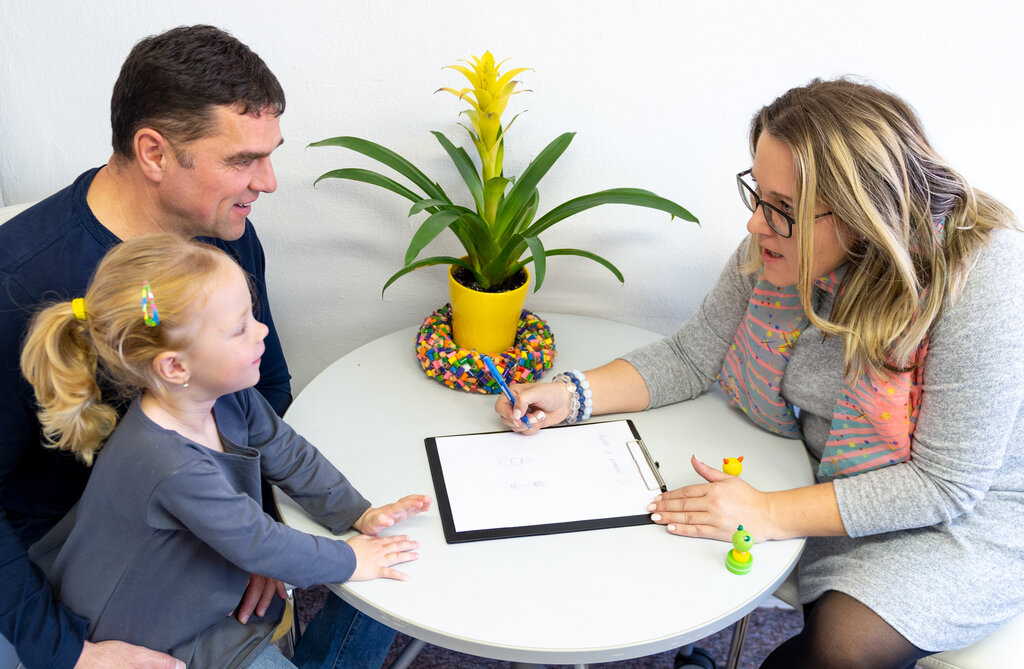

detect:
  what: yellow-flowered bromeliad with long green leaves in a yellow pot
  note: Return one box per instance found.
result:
[309,51,697,352]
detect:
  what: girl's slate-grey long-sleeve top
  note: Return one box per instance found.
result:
[32,388,370,667]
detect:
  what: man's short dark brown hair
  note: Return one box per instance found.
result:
[111,26,285,162]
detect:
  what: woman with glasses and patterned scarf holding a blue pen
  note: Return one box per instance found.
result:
[496,75,1024,667]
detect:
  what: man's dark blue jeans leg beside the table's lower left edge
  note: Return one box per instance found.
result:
[292,593,395,669]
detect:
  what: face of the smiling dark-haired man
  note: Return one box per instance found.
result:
[160,107,283,241]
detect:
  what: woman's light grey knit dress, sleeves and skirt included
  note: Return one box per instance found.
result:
[625,231,1024,651]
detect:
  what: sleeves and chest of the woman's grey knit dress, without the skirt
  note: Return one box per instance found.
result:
[625,231,1024,537]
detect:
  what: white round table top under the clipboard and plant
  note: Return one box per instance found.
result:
[278,313,813,664]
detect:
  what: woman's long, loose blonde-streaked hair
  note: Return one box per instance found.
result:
[748,79,1016,377]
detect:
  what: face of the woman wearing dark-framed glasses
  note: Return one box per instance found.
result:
[746,132,847,286]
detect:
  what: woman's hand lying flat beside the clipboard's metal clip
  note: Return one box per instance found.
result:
[647,456,774,542]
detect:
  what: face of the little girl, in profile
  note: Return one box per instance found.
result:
[186,256,269,399]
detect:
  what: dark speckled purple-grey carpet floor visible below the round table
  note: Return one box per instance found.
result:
[296,587,803,669]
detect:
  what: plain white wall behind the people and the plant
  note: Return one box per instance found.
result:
[0,0,1024,389]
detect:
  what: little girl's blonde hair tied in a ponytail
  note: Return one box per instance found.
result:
[22,234,227,465]
